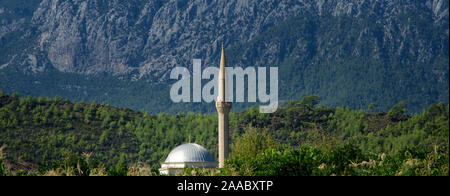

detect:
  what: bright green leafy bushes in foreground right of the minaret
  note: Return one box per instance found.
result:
[223,134,449,176]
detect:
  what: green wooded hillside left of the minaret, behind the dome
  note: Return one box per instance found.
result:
[0,90,217,168]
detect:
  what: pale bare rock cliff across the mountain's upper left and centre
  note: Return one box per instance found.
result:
[32,0,312,78]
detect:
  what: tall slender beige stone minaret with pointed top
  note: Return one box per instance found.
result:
[216,43,231,167]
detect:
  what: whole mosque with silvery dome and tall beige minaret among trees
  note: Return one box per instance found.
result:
[159,43,232,175]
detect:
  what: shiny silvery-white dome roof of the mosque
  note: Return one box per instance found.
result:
[164,143,216,163]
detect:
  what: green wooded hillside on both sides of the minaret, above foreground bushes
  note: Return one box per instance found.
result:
[0,92,449,175]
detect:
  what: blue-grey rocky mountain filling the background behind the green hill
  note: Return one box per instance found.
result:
[0,0,449,113]
